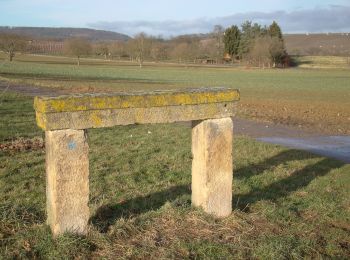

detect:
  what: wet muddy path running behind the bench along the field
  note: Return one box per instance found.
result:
[0,81,350,163]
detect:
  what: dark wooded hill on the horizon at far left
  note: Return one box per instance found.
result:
[0,26,130,41]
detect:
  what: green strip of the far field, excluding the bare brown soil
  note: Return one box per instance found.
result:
[0,57,350,102]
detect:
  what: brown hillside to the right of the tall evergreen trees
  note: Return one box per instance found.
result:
[284,33,350,56]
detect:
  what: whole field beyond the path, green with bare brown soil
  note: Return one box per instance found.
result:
[0,55,350,134]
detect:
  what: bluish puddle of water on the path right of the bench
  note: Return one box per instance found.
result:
[257,136,350,163]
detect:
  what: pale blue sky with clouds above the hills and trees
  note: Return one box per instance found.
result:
[0,0,350,37]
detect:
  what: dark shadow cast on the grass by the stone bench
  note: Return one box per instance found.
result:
[90,150,345,232]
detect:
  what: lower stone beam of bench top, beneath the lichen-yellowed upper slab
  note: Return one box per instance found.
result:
[36,103,236,130]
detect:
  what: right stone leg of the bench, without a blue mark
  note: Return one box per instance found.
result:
[192,118,233,217]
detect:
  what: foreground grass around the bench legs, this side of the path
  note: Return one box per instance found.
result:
[0,94,350,259]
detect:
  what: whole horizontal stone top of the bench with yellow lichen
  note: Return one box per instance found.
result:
[34,88,239,130]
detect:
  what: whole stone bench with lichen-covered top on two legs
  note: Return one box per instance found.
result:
[34,88,239,235]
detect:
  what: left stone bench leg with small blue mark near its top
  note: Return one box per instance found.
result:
[45,130,89,235]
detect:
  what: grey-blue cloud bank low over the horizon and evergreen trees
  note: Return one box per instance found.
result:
[88,5,350,37]
